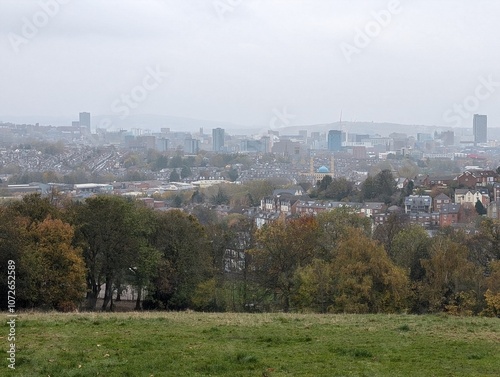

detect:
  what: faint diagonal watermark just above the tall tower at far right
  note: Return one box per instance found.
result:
[443,75,500,126]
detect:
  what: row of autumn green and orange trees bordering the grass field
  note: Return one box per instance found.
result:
[0,195,500,316]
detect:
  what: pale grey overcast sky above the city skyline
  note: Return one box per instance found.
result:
[0,0,500,126]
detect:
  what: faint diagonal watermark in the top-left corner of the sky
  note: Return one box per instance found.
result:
[7,0,71,54]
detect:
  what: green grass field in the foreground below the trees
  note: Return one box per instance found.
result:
[5,312,500,377]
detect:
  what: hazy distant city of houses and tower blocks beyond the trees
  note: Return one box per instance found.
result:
[0,112,500,228]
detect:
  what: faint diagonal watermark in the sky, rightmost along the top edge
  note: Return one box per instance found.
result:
[339,0,403,63]
